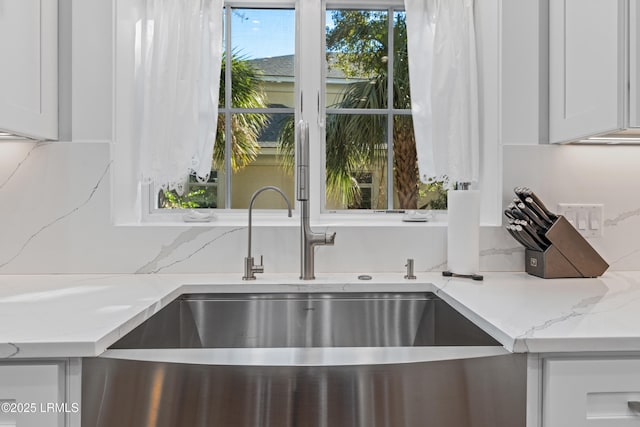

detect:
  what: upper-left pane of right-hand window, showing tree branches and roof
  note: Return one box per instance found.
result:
[326,9,388,108]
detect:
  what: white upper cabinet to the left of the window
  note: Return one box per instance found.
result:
[0,0,58,139]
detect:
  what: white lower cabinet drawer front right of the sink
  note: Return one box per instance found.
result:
[542,358,640,427]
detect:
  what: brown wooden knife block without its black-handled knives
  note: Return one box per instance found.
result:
[525,216,609,279]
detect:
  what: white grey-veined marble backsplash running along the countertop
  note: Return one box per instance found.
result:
[0,142,640,274]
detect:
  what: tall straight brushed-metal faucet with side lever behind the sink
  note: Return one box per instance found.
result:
[296,120,336,280]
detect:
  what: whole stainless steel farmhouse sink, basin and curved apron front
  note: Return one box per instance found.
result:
[82,292,526,427]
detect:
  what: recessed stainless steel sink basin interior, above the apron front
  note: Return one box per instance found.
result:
[110,292,499,349]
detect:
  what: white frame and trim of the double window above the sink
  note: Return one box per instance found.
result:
[112,0,502,226]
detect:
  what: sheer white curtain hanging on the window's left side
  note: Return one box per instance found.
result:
[138,0,223,193]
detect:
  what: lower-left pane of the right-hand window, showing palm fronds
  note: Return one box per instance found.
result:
[325,114,387,210]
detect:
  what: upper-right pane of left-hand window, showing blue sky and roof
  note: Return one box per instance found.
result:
[231,9,295,108]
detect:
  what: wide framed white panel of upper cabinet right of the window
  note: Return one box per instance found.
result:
[549,0,624,142]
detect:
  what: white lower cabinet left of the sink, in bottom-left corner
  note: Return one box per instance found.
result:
[0,360,80,427]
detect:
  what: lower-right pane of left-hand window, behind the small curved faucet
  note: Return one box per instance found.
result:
[231,114,295,209]
